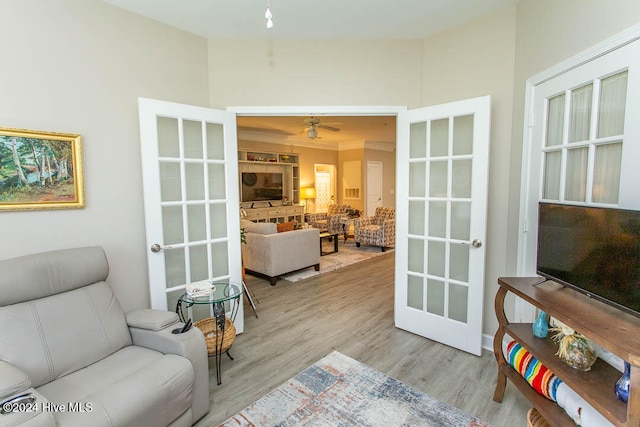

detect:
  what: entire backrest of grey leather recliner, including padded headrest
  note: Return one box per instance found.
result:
[0,247,131,387]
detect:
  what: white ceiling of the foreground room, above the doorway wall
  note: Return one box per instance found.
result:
[103,0,518,40]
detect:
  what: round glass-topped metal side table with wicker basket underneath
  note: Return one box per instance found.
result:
[176,281,242,385]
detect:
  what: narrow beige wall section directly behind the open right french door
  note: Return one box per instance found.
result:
[423,7,516,334]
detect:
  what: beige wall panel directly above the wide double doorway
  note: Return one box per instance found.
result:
[209,40,422,108]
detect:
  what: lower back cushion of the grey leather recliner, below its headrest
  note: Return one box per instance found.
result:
[0,282,131,387]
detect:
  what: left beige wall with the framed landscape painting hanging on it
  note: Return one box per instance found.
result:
[0,0,208,310]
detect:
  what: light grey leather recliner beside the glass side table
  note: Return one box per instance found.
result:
[0,247,209,427]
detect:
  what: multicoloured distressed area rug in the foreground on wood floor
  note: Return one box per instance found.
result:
[221,351,489,427]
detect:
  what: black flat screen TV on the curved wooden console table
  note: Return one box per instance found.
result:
[537,202,640,317]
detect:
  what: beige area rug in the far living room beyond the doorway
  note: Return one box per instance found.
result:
[281,237,393,282]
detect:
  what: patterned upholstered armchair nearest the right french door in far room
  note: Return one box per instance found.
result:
[354,207,396,252]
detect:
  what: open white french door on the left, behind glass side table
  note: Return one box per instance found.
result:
[139,98,244,332]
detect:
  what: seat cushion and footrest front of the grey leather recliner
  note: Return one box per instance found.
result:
[38,346,194,426]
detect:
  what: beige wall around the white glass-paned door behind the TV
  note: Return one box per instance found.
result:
[507,0,640,275]
